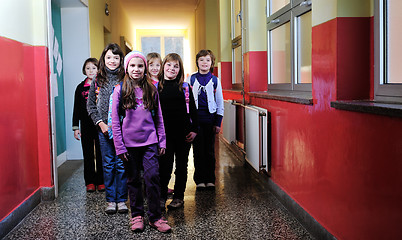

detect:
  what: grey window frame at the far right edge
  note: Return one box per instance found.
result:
[374,0,402,103]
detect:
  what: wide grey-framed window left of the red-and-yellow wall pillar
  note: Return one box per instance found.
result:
[267,0,312,91]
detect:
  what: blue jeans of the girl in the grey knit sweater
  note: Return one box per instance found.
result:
[98,131,127,203]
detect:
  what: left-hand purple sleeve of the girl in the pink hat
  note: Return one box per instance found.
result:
[112,85,127,155]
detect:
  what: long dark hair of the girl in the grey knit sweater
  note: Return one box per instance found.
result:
[96,43,124,86]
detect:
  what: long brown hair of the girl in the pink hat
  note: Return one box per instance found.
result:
[120,57,157,111]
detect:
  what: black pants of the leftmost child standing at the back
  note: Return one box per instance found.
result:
[81,128,103,185]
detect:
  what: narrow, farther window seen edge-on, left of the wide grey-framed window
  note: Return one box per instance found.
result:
[232,0,243,84]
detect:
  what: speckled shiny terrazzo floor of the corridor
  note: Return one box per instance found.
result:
[4,138,313,240]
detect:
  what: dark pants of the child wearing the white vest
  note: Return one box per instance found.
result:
[193,124,216,184]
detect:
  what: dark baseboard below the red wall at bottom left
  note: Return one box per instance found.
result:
[0,189,41,239]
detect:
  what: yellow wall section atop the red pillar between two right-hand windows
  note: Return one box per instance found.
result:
[312,0,374,26]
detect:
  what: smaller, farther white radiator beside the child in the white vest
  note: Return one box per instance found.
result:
[223,100,236,143]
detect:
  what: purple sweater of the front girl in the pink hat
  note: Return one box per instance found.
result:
[112,85,166,155]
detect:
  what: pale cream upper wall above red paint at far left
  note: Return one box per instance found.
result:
[0,0,47,46]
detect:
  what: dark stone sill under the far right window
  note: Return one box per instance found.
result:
[331,100,402,118]
